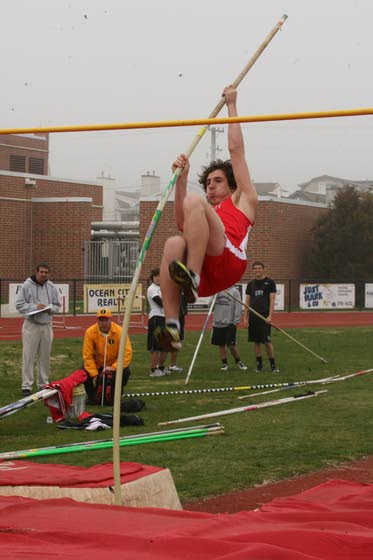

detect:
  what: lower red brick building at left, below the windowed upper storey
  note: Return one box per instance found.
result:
[0,171,102,280]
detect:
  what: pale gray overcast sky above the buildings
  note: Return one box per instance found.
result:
[0,0,373,190]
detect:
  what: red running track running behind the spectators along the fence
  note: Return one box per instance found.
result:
[0,311,373,341]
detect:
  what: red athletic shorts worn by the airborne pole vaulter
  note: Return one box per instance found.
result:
[198,247,247,297]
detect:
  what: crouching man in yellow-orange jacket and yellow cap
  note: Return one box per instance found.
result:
[83,307,132,405]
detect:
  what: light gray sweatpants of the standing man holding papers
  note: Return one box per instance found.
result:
[22,320,53,390]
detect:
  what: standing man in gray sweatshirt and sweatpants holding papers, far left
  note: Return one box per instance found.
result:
[16,262,61,396]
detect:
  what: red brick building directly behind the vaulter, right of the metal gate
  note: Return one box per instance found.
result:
[140,197,326,281]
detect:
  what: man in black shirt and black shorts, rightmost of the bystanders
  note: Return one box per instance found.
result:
[244,261,279,373]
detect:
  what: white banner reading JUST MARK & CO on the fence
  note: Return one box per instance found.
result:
[299,284,355,310]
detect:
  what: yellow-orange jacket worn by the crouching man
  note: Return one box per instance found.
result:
[83,322,132,377]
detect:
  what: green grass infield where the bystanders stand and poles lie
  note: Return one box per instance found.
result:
[0,327,373,501]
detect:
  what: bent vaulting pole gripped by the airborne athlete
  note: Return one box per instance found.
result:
[113,15,287,505]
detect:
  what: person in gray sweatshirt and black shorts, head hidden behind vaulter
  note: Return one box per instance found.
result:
[211,286,247,371]
